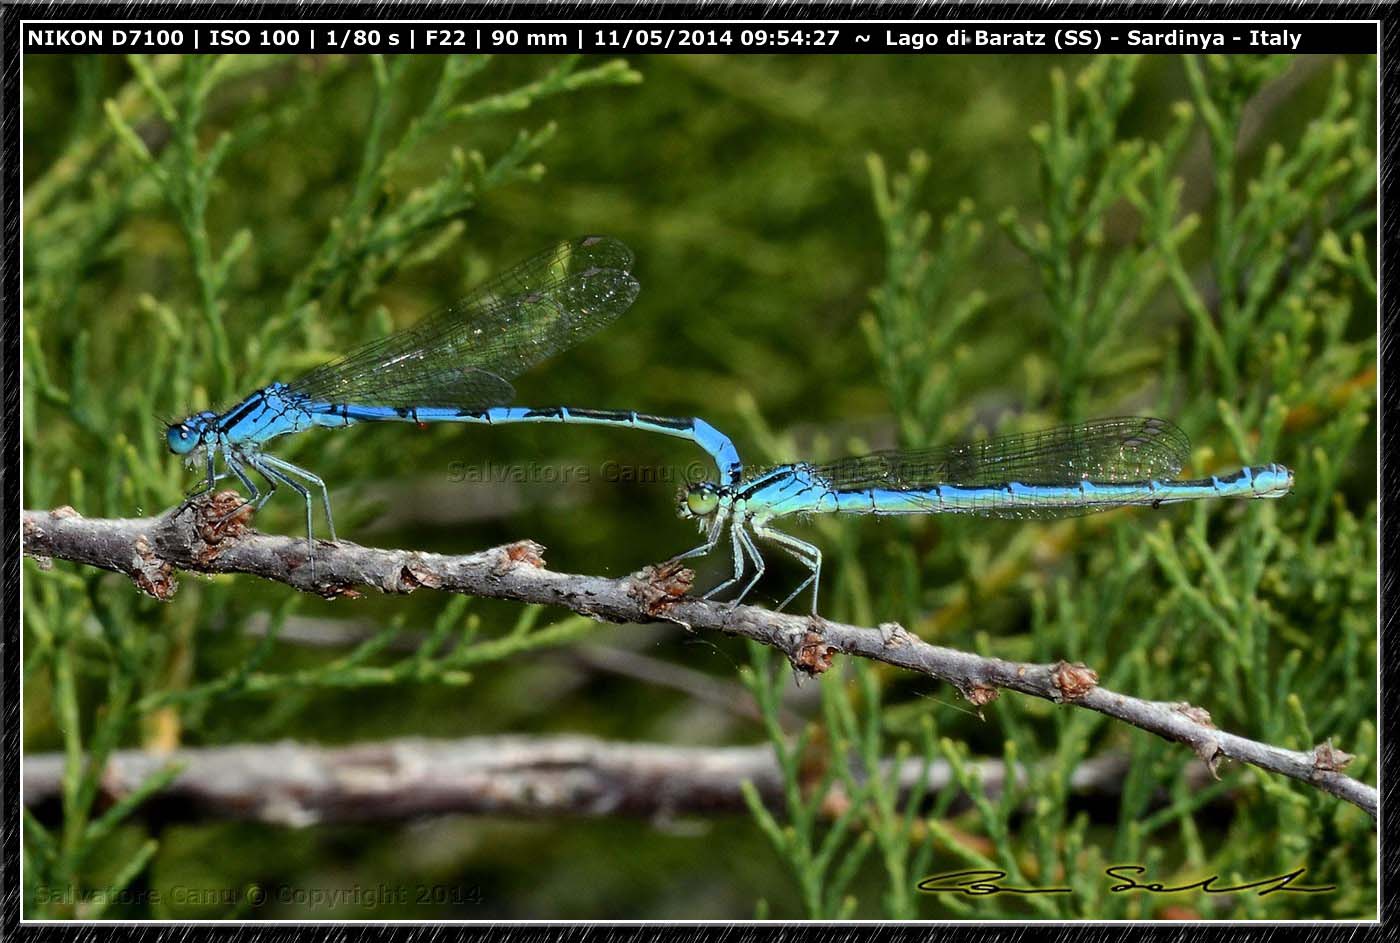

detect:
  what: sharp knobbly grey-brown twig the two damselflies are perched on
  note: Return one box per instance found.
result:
[22,491,1378,818]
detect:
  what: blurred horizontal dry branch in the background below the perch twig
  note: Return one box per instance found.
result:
[16,736,1127,827]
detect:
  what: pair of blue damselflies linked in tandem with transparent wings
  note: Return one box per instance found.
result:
[165,236,1294,613]
